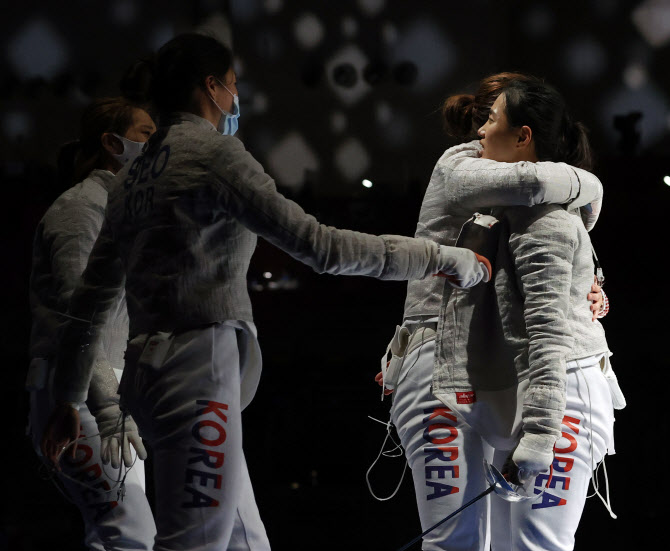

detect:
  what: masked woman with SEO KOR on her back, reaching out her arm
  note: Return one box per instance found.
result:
[45,35,488,551]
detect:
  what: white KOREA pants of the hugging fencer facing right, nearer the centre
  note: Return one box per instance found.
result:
[391,337,493,551]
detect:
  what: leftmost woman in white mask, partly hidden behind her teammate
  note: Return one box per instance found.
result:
[27,98,156,551]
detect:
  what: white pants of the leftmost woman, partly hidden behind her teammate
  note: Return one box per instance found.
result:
[30,376,156,551]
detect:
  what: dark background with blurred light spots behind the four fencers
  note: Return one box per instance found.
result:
[0,0,670,550]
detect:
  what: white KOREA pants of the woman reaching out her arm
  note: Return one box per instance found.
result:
[122,324,270,551]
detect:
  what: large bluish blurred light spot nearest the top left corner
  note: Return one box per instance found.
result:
[7,19,69,79]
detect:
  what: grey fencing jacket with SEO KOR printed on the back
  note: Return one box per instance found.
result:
[54,113,446,402]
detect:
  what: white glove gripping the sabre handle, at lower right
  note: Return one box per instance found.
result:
[503,433,556,485]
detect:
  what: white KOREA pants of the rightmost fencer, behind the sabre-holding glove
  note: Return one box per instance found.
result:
[491,364,614,551]
